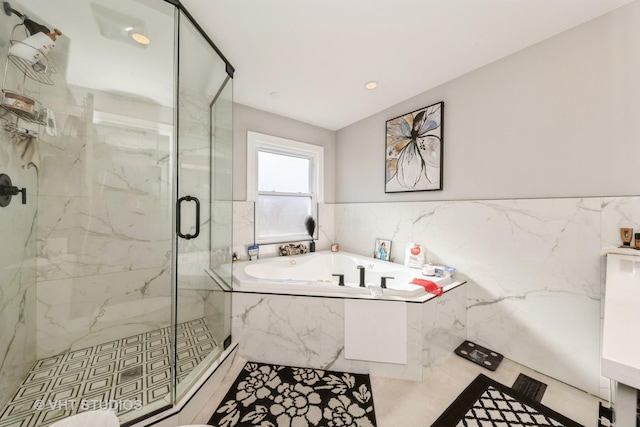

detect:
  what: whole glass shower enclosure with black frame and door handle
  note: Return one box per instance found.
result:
[0,0,233,427]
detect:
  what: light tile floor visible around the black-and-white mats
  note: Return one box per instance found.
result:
[193,354,601,427]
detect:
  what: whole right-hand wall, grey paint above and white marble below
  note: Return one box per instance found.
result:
[335,1,640,397]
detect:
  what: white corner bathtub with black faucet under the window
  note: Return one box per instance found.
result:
[233,251,462,301]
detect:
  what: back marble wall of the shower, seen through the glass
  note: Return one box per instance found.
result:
[32,85,220,358]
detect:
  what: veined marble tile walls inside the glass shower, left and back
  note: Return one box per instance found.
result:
[0,15,231,412]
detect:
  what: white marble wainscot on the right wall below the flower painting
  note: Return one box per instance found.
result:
[335,197,640,397]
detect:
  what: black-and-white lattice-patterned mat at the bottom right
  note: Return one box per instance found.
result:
[431,374,583,427]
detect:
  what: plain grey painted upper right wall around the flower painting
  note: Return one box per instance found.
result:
[336,1,640,203]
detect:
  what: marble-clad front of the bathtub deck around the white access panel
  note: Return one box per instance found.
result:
[232,285,467,380]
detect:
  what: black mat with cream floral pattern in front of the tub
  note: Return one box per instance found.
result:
[209,362,376,427]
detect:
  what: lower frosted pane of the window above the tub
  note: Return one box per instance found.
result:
[256,195,312,242]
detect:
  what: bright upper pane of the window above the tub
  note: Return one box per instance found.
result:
[258,151,311,193]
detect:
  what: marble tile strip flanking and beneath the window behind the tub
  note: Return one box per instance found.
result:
[233,201,335,260]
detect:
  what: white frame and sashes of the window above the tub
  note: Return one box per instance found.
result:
[247,131,324,244]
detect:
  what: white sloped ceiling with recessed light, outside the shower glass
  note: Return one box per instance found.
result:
[182,0,640,130]
